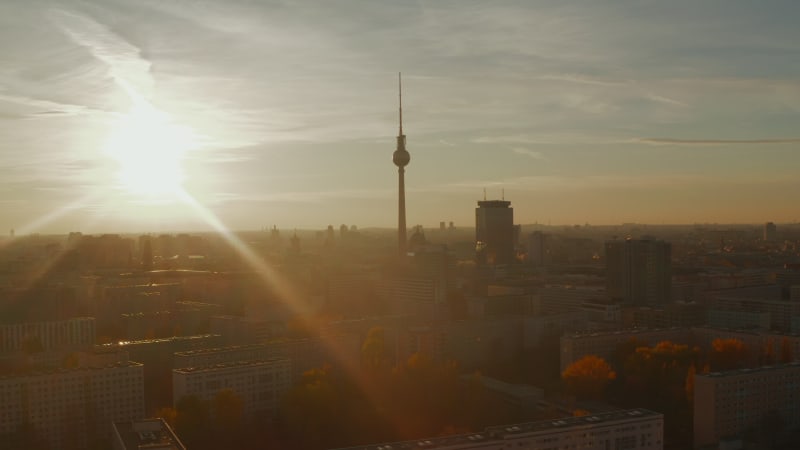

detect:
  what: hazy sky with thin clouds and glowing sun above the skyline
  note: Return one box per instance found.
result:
[0,0,800,235]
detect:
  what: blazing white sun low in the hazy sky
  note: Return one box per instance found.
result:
[105,92,194,199]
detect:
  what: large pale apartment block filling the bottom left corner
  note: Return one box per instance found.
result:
[0,362,144,449]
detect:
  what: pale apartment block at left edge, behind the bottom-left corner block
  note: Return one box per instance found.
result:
[0,317,96,353]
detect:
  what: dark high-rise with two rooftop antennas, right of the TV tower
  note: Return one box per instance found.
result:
[475,200,515,265]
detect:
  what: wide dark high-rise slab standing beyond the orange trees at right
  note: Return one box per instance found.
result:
[605,238,672,306]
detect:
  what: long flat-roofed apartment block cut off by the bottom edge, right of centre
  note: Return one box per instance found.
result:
[332,409,664,450]
